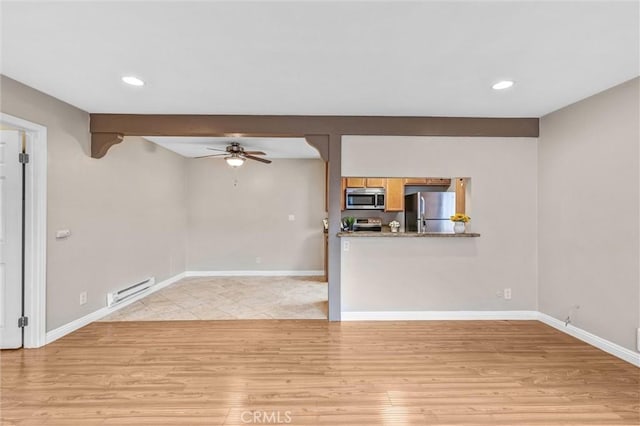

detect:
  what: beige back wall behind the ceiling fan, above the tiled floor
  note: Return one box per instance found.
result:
[187,159,326,271]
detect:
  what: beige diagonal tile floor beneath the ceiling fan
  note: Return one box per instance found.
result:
[102,277,328,321]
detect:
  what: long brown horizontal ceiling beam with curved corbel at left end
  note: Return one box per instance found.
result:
[90,114,539,158]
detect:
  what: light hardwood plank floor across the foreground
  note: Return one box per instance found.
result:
[1,320,640,426]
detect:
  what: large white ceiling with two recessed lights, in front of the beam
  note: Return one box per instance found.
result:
[0,0,640,117]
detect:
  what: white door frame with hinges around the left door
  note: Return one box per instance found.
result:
[0,112,48,348]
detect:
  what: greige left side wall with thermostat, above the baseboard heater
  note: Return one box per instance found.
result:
[0,76,186,330]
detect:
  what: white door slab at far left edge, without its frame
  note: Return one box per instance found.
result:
[0,130,22,349]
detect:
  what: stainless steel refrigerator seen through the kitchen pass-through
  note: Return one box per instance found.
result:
[404,192,456,232]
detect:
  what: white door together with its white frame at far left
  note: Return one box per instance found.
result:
[0,113,47,348]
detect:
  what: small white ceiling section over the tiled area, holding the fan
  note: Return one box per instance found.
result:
[144,136,320,160]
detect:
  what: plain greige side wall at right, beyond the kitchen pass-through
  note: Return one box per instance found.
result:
[538,79,640,350]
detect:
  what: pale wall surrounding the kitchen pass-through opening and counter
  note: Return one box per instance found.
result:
[341,136,537,312]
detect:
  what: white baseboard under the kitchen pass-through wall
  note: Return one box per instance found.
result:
[341,311,538,321]
